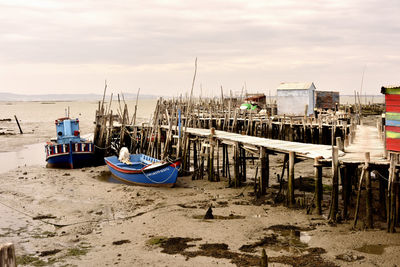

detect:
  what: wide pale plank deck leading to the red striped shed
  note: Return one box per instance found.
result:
[339,125,389,165]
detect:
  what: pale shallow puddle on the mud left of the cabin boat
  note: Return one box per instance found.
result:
[0,143,46,173]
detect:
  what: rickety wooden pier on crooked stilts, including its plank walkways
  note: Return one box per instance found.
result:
[95,93,400,232]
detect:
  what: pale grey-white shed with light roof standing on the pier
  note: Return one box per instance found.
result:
[276,82,315,116]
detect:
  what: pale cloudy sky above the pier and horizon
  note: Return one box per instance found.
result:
[0,0,400,96]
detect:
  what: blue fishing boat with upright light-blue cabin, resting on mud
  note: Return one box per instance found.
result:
[45,118,94,169]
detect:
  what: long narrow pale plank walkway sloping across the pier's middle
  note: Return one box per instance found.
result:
[174,126,344,159]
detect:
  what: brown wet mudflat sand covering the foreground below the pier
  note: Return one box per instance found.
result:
[0,122,400,266]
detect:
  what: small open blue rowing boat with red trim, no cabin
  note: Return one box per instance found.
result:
[104,154,181,187]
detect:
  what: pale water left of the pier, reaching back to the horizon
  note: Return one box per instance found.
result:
[0,99,157,173]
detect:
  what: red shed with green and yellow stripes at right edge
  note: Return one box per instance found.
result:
[381,86,400,152]
